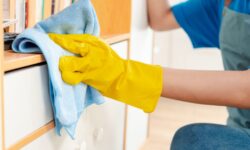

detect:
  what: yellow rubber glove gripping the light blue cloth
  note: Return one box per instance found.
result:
[49,33,163,112]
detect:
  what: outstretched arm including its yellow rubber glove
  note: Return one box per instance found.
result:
[50,34,250,112]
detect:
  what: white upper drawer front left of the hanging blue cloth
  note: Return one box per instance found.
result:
[4,65,53,147]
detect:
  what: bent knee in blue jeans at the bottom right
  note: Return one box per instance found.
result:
[171,124,250,150]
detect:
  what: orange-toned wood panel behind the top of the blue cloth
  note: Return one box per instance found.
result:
[92,0,131,35]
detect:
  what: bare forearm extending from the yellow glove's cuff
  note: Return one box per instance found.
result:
[162,68,250,108]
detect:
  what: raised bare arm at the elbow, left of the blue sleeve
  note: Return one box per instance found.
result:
[147,0,179,31]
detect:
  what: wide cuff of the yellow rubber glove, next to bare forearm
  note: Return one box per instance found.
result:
[103,60,163,113]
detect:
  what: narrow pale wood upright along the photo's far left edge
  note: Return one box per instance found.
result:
[0,0,5,150]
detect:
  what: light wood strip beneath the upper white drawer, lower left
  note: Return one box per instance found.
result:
[8,121,55,150]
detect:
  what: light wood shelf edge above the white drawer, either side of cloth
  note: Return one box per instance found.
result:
[4,34,130,72]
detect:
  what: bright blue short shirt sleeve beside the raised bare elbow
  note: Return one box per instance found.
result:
[172,0,224,48]
